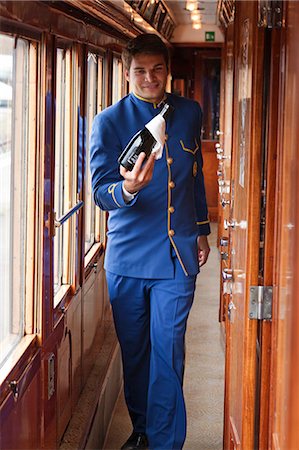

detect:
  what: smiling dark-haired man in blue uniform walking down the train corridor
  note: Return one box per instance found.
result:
[90,34,210,450]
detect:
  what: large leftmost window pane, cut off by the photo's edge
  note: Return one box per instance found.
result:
[0,35,37,366]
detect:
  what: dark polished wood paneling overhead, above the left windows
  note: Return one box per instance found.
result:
[1,0,137,48]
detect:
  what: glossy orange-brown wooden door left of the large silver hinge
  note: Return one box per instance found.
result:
[224,2,263,450]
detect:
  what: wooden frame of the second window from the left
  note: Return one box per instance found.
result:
[52,38,82,308]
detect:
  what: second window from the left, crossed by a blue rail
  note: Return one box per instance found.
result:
[54,48,79,300]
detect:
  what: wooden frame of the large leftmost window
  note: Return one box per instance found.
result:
[0,27,43,386]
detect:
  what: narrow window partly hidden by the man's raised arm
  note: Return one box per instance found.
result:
[84,52,105,254]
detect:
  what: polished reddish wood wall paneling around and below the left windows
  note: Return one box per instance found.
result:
[0,1,123,450]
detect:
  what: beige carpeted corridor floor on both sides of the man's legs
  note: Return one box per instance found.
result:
[104,224,224,450]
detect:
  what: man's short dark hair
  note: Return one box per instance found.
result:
[122,33,169,70]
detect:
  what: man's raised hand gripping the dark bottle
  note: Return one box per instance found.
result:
[120,152,155,194]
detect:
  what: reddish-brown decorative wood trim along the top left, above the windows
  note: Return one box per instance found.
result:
[0,0,129,47]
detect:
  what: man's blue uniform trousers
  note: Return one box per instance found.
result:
[106,257,196,450]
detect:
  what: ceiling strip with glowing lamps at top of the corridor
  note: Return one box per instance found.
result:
[165,0,218,25]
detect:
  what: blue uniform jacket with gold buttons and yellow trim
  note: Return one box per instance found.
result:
[90,93,210,278]
